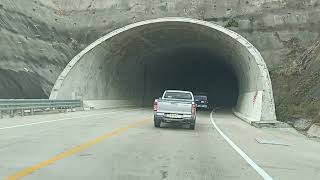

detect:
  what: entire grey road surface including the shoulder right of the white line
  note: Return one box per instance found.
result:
[0,109,320,180]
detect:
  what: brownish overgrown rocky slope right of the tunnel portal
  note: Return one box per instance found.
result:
[271,39,320,122]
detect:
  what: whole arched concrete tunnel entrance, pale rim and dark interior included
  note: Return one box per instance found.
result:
[50,17,276,121]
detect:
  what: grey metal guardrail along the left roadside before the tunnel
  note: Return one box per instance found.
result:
[0,99,83,118]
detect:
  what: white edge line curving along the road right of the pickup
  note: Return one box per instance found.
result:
[210,111,273,180]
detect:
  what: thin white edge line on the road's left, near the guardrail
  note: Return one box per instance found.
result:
[0,110,141,130]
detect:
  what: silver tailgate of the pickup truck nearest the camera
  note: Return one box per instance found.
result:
[158,100,192,114]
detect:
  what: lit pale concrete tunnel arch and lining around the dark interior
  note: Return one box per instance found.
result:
[50,18,276,121]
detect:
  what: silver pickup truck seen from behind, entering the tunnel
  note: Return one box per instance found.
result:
[153,90,197,129]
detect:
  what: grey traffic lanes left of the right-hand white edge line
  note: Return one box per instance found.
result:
[0,109,259,180]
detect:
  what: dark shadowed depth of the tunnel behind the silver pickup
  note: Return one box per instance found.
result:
[139,47,239,108]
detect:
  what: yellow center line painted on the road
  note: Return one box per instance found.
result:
[5,119,149,180]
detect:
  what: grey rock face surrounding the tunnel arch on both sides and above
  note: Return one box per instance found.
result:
[0,0,320,120]
